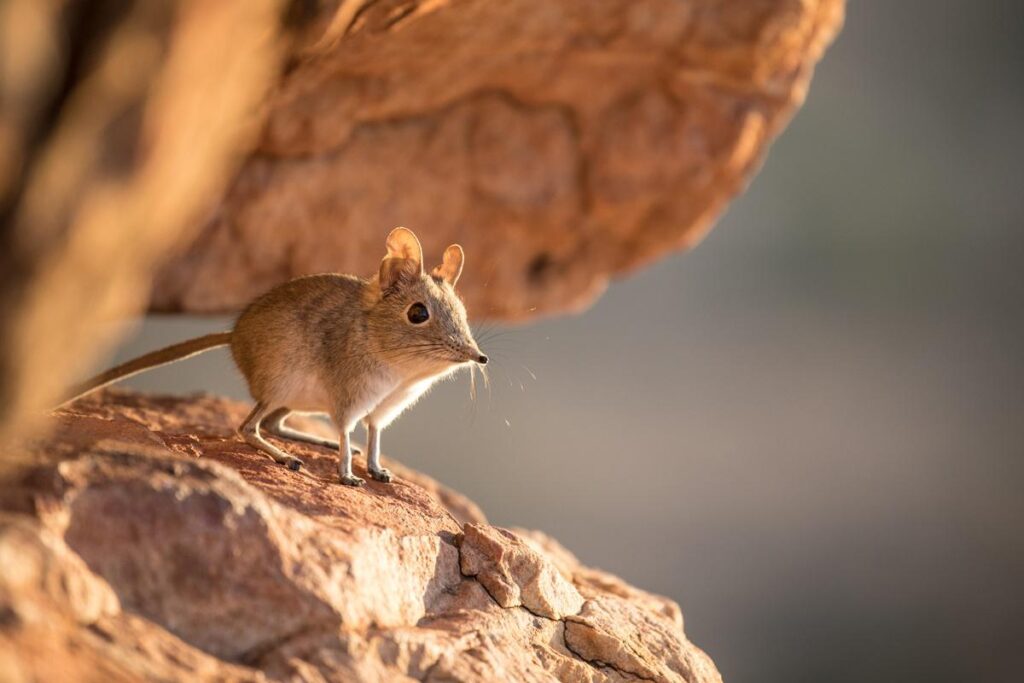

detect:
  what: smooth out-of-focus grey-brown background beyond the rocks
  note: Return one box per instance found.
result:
[103,0,1024,683]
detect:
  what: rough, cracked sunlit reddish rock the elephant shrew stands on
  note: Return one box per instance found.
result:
[0,391,721,683]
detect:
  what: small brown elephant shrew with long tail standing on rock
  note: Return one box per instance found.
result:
[65,227,487,486]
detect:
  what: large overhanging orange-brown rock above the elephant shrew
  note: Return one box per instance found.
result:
[153,0,843,319]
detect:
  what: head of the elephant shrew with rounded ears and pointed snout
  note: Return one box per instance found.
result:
[369,227,487,370]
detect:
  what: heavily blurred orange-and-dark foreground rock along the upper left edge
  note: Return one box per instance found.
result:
[0,0,281,448]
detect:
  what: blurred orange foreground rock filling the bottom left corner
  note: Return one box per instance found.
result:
[0,513,265,683]
